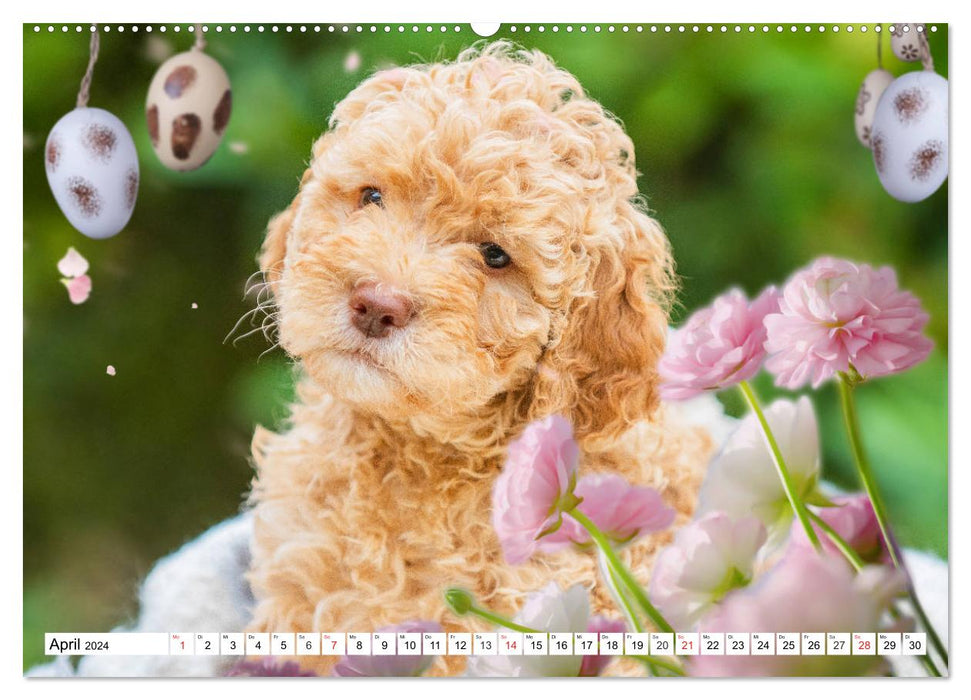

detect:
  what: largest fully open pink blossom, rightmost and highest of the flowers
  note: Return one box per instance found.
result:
[765,258,933,389]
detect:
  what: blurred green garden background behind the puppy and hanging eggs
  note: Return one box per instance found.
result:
[23,25,948,667]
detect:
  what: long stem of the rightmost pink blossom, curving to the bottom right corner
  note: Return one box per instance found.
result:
[837,372,948,667]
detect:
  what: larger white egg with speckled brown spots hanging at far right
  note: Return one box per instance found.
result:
[870,70,948,202]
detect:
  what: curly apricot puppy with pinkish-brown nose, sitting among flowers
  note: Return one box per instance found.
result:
[250,43,711,674]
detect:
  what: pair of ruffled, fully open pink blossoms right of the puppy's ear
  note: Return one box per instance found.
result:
[658,257,933,400]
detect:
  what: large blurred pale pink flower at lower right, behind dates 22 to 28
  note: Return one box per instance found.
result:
[689,549,903,677]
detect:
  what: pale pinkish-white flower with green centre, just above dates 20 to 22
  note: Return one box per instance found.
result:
[650,513,766,631]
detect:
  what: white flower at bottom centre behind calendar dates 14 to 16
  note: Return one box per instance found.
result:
[466,583,590,678]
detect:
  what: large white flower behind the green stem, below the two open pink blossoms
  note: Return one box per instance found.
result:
[698,396,820,544]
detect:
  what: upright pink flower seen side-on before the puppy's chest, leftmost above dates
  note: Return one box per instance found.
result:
[492,416,579,564]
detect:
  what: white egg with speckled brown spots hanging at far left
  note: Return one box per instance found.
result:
[44,107,138,238]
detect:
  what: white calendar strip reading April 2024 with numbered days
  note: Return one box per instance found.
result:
[44,630,927,657]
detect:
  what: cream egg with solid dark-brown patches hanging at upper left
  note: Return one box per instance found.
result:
[145,49,233,170]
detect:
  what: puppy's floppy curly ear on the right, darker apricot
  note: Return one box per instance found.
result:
[530,202,674,446]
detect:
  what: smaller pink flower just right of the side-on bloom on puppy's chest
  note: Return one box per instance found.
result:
[540,474,675,550]
